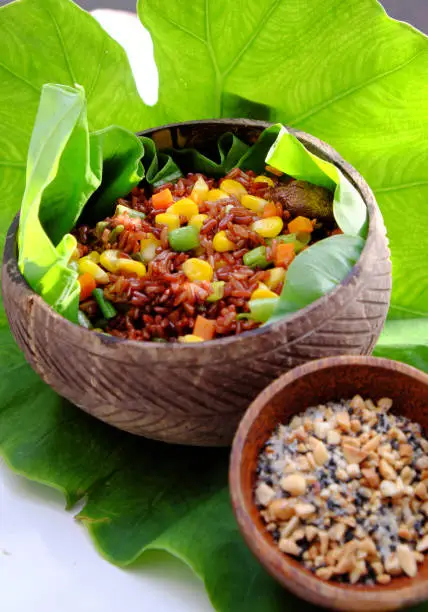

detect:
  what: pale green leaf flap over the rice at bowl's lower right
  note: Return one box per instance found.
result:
[268,235,365,323]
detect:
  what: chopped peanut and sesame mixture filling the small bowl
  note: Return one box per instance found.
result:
[255,395,428,585]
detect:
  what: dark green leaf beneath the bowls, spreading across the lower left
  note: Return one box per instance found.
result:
[0,304,312,612]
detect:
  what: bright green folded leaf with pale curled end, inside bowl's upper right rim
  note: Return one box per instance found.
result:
[266,126,368,237]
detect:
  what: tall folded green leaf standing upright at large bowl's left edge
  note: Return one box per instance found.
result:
[18,85,101,322]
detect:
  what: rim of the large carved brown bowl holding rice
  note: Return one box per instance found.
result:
[3,119,382,362]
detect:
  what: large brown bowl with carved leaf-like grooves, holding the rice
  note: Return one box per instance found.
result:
[3,119,391,446]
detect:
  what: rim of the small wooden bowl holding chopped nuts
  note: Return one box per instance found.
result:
[229,355,428,611]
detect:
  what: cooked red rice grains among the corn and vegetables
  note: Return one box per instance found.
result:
[75,168,328,341]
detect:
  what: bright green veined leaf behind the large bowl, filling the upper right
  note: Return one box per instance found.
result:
[139,0,428,317]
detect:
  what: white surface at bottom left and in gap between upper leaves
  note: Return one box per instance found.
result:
[0,11,213,612]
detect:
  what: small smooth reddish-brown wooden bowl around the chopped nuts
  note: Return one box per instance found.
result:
[229,356,428,612]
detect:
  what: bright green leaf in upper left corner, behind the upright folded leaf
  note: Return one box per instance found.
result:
[0,0,157,251]
